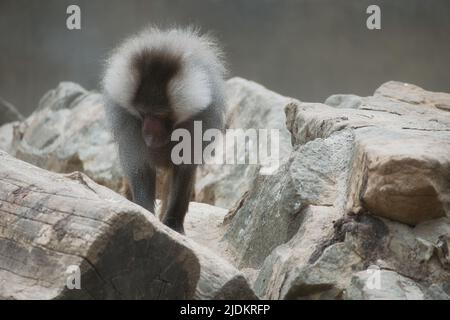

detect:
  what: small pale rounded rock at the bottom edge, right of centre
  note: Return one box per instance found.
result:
[346,268,424,300]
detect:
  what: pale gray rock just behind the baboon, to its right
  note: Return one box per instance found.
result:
[195,78,292,208]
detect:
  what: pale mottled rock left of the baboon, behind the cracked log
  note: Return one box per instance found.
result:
[5,82,123,191]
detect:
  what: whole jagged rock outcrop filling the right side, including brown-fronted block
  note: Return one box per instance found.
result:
[223,83,450,299]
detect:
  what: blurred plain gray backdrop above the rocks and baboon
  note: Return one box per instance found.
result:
[0,0,450,114]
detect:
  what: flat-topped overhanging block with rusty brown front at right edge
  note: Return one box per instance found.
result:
[286,83,450,225]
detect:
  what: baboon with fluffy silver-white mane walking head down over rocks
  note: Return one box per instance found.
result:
[102,28,225,232]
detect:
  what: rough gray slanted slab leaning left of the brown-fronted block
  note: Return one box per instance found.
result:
[225,131,353,268]
